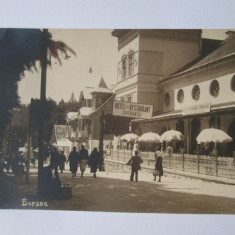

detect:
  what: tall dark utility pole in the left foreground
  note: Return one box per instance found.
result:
[38,29,48,194]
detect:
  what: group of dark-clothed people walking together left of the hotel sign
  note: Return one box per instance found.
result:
[49,145,100,178]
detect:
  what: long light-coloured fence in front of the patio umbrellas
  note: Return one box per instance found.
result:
[106,150,235,179]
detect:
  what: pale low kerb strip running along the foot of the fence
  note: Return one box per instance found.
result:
[105,159,235,185]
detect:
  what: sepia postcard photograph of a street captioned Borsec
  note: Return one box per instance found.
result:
[0,28,235,215]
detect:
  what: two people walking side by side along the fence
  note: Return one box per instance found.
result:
[127,151,163,182]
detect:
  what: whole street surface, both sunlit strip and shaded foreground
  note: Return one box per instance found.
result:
[19,169,235,214]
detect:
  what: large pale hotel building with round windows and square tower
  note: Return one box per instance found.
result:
[112,30,235,156]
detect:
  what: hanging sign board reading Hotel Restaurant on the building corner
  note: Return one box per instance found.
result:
[113,101,153,119]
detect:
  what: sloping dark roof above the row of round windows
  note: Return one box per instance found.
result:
[162,32,235,82]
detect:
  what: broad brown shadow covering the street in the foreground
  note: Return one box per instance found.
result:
[14,174,235,214]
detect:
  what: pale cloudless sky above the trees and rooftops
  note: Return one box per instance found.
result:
[19,29,231,103]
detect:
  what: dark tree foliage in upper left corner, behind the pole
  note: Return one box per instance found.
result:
[0,29,76,140]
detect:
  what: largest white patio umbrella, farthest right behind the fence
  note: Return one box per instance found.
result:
[196,128,233,144]
